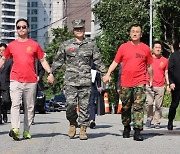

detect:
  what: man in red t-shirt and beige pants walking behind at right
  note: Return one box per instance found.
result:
[146,41,170,129]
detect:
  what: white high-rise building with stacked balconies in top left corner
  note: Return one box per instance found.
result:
[0,0,27,44]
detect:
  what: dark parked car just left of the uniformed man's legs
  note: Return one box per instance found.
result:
[50,92,66,111]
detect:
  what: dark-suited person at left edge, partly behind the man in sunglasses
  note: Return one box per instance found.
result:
[0,43,13,124]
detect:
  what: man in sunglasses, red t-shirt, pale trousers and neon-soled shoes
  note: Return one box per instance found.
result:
[0,18,54,140]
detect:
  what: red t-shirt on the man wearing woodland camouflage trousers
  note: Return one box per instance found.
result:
[114,41,152,87]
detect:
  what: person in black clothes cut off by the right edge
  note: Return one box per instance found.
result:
[167,39,180,130]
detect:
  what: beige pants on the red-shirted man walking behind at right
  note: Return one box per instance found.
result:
[146,86,165,125]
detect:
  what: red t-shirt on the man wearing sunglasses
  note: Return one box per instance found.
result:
[4,39,44,83]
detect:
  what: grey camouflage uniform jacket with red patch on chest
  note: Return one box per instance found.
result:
[52,38,106,86]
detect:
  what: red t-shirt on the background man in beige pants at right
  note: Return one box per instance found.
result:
[147,56,168,87]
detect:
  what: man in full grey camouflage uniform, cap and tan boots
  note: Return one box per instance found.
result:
[52,19,106,140]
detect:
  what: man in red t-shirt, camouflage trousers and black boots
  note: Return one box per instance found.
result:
[103,24,152,141]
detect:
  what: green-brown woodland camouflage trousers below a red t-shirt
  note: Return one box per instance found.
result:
[120,85,146,130]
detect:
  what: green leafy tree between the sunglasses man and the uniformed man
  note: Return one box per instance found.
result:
[44,27,73,95]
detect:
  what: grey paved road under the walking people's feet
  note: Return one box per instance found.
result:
[0,112,180,154]
